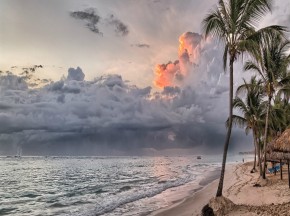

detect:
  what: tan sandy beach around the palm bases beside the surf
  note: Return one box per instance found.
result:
[152,162,290,216]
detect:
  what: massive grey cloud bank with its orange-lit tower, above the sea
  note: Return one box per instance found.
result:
[0,26,253,154]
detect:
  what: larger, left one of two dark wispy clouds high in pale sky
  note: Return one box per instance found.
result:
[70,8,103,35]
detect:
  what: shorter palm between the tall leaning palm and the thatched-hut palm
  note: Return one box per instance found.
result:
[233,76,263,175]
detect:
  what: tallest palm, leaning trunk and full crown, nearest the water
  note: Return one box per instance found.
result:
[202,0,283,197]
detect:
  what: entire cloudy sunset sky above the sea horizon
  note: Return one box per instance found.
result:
[0,0,290,155]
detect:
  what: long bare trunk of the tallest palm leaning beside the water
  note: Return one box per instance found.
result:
[216,56,234,197]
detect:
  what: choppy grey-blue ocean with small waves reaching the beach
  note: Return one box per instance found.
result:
[0,155,253,216]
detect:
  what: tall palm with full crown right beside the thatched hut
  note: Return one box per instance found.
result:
[244,34,290,179]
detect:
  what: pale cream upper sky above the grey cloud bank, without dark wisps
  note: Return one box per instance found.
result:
[0,0,218,86]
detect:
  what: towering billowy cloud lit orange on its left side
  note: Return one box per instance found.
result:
[154,32,216,88]
